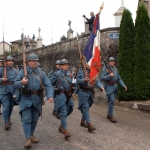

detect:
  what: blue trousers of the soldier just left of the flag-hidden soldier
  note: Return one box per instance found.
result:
[58,103,67,129]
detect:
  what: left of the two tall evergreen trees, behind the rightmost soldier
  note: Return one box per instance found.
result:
[118,9,134,100]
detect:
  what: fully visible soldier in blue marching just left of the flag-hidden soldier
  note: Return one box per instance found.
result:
[51,59,74,139]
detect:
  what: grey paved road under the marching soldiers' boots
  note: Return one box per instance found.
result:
[0,101,150,150]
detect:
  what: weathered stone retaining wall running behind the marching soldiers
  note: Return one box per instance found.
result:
[0,28,119,73]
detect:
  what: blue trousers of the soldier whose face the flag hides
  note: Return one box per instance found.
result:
[81,98,90,123]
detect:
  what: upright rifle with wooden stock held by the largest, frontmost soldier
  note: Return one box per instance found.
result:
[22,33,27,78]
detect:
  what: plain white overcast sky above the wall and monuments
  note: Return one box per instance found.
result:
[0,0,138,45]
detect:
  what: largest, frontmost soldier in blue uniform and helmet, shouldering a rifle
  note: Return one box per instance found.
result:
[15,53,53,148]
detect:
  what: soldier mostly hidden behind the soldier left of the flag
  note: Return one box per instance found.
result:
[48,60,60,119]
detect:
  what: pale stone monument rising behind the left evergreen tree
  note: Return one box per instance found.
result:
[114,0,125,27]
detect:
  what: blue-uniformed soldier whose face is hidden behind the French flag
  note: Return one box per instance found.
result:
[76,64,104,132]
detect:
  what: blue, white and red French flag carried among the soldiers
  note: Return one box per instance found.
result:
[84,14,101,85]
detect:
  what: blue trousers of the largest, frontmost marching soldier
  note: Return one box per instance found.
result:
[21,105,40,139]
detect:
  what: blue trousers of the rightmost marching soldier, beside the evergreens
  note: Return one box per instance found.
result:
[107,92,117,116]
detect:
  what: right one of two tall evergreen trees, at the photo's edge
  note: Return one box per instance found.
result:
[134,4,150,100]
